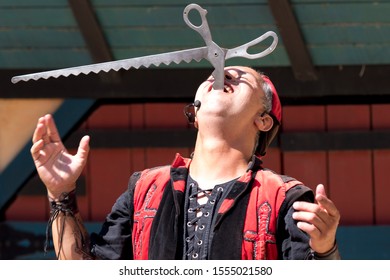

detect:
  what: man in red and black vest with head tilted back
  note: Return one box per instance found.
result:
[31,66,340,259]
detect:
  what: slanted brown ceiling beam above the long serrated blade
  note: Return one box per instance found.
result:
[68,0,120,83]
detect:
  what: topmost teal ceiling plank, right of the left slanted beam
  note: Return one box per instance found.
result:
[90,1,390,29]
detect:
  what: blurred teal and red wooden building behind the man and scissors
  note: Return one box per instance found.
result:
[0,0,390,259]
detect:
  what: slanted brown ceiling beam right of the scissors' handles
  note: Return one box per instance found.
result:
[268,0,318,81]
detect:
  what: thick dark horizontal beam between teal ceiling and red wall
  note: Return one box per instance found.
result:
[4,65,390,105]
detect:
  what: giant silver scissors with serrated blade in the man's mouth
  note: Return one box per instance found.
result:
[11,4,278,90]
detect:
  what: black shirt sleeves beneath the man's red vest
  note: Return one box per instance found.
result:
[91,175,314,260]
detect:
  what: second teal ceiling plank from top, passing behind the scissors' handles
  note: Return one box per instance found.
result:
[100,24,390,48]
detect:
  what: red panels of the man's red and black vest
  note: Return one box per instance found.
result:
[132,155,302,260]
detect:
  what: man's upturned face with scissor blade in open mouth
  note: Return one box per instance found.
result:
[195,66,264,123]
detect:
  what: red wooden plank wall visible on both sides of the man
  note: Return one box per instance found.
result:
[6,103,390,225]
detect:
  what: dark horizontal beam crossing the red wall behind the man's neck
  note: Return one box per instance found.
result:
[65,127,390,151]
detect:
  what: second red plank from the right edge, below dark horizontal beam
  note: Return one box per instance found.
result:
[328,150,375,225]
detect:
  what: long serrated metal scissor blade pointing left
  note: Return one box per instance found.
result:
[11,47,208,84]
